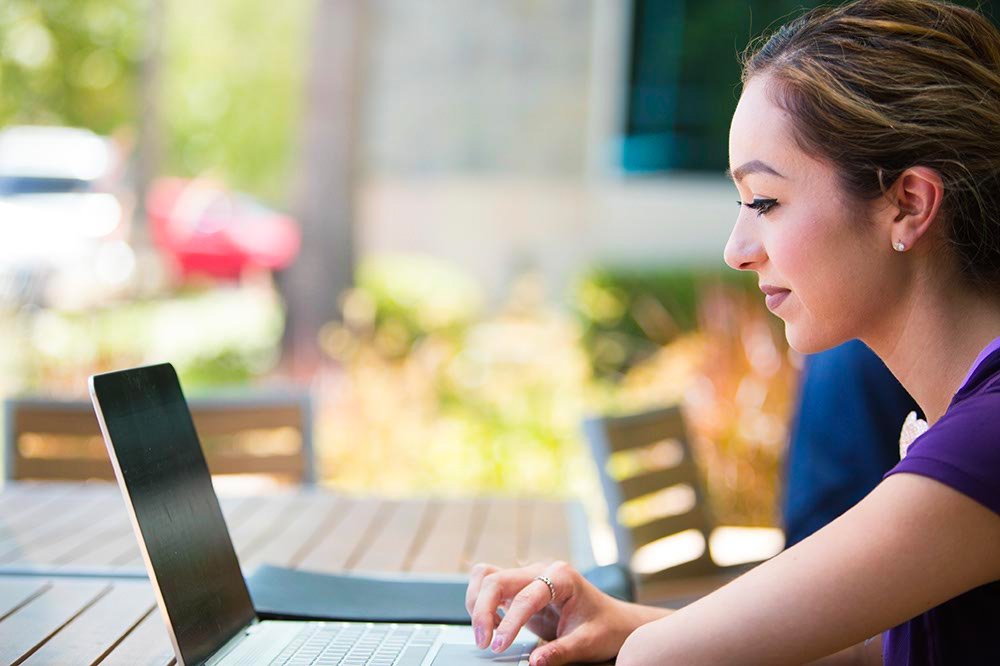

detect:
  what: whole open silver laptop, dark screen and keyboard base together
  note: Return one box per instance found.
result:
[90,363,538,666]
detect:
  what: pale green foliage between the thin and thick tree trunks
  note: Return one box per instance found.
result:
[161,0,311,204]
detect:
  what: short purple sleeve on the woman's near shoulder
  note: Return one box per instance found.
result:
[885,393,1000,514]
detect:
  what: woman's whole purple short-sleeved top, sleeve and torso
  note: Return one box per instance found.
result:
[882,338,1000,666]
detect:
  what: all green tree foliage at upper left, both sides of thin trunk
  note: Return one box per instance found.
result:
[0,0,311,203]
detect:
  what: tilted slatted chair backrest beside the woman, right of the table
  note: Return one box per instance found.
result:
[583,407,718,580]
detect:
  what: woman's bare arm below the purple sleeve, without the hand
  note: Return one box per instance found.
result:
[618,474,1000,666]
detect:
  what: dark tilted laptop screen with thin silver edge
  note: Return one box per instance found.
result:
[90,364,255,664]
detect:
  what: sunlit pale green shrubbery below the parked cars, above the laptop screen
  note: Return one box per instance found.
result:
[18,289,284,394]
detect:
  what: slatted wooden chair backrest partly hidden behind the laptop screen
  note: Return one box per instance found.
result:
[4,392,315,484]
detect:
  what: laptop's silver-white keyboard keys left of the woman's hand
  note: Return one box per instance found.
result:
[271,622,443,666]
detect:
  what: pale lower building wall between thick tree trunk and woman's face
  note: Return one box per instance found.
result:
[359,177,736,300]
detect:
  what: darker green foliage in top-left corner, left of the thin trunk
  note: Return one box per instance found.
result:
[0,0,143,134]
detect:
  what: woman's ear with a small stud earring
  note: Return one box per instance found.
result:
[885,166,944,252]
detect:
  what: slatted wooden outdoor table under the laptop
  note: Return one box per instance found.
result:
[0,482,593,666]
